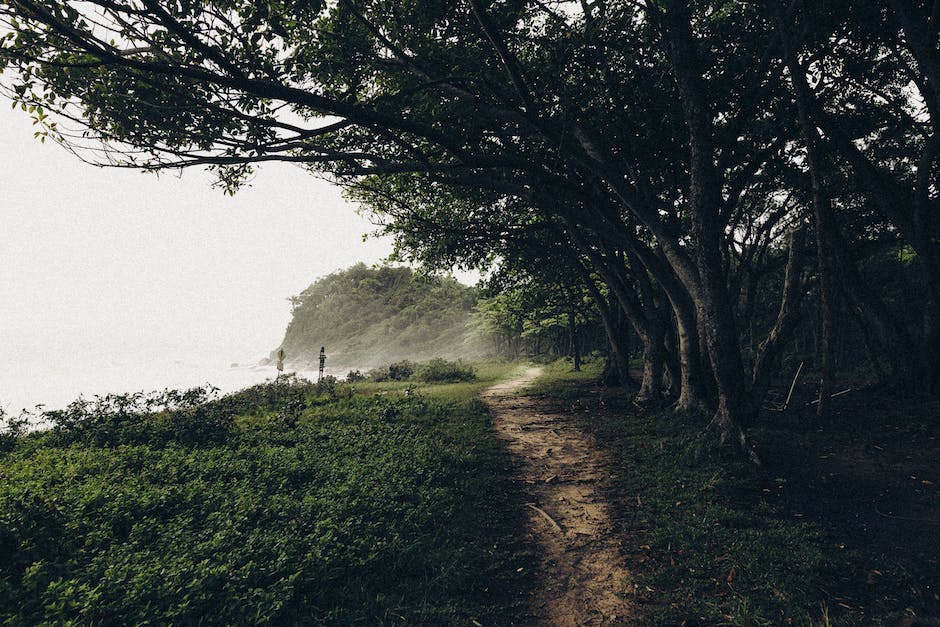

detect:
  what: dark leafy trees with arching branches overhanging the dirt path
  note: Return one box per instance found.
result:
[0,0,940,456]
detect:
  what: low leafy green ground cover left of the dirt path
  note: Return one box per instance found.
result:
[0,365,523,624]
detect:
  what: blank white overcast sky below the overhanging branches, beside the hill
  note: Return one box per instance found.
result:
[0,104,390,368]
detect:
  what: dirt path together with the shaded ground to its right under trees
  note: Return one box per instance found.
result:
[506,364,940,627]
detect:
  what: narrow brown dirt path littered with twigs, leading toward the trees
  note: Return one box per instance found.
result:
[483,368,629,626]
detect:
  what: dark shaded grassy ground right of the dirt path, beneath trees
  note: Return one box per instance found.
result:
[535,365,940,626]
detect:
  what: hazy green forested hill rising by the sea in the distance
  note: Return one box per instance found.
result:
[281,263,483,368]
